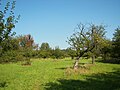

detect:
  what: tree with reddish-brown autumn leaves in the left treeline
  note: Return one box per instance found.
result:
[18,34,36,65]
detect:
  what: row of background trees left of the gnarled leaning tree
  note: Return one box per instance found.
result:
[0,34,75,63]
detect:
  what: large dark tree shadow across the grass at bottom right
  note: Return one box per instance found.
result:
[45,70,120,90]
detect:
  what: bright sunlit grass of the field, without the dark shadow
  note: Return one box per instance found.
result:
[0,58,120,90]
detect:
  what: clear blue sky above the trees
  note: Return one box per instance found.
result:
[2,0,120,49]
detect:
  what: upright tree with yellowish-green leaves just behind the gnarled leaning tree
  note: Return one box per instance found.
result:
[90,24,107,64]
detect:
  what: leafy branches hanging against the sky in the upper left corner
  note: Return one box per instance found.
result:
[0,0,20,46]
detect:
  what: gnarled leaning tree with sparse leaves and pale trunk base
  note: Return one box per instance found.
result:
[67,24,104,69]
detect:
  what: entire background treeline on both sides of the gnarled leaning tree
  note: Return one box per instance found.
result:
[0,28,120,63]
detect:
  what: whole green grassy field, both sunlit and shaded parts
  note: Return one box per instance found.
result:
[0,59,120,90]
